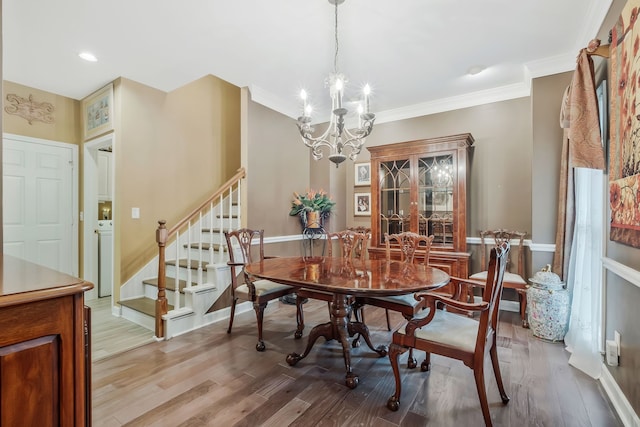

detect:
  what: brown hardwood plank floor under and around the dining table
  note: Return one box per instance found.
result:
[93,301,622,427]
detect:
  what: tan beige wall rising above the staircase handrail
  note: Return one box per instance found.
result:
[114,76,240,283]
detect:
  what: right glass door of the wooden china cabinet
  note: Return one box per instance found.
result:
[418,154,456,246]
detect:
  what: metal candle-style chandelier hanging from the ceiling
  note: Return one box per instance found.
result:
[296,0,376,167]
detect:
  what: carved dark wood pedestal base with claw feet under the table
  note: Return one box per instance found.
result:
[287,294,387,388]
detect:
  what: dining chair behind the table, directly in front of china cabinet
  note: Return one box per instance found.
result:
[354,231,433,368]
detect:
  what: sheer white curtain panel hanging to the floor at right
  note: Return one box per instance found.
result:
[564,168,604,379]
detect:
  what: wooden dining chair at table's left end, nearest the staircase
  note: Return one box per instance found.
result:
[224,228,295,351]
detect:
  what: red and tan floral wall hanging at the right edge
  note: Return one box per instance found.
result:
[609,0,640,247]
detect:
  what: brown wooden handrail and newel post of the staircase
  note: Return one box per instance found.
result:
[155,168,246,338]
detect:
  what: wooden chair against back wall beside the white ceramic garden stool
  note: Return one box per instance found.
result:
[469,229,529,328]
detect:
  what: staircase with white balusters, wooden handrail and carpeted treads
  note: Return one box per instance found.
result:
[119,169,244,339]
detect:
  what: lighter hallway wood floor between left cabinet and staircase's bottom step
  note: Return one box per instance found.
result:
[85,297,155,362]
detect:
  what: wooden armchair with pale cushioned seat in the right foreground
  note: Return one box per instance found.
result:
[387,241,510,426]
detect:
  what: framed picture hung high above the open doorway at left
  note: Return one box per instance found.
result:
[82,84,113,141]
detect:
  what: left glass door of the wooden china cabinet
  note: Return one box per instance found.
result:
[378,159,411,244]
